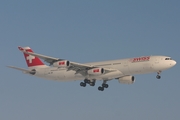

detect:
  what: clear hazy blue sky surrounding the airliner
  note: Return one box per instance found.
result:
[0,0,180,120]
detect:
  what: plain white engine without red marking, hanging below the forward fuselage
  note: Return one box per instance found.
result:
[118,76,135,84]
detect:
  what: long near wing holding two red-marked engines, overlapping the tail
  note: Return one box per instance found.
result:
[18,47,117,76]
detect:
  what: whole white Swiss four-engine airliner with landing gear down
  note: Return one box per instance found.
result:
[8,47,176,91]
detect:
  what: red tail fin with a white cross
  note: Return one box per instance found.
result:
[18,47,46,68]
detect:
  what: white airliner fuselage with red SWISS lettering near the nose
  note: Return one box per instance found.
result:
[31,56,176,81]
